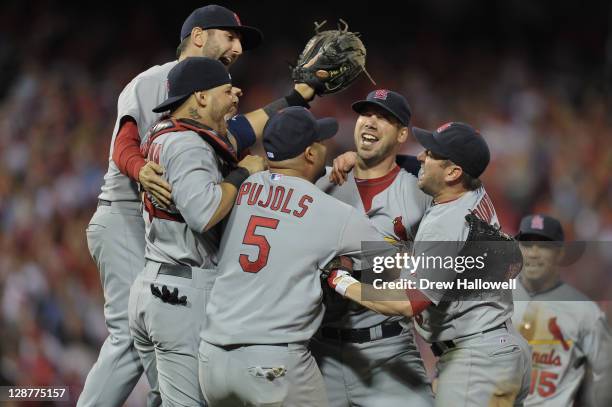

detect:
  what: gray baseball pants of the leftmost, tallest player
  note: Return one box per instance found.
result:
[77,201,161,407]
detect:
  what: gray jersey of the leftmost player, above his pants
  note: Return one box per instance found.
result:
[99,61,178,201]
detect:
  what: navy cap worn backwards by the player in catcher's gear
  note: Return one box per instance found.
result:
[153,57,232,113]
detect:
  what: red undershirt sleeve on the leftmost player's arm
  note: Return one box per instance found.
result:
[113,117,145,182]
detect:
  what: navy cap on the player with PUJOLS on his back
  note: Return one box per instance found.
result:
[263,106,338,161]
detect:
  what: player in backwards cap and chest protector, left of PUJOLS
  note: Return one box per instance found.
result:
[128,57,264,406]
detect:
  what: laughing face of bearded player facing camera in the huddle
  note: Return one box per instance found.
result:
[354,106,405,165]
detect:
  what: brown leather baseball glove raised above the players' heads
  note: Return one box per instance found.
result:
[291,20,376,95]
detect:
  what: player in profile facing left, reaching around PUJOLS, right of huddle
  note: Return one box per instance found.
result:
[328,122,530,406]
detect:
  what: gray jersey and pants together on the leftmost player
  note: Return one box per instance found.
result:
[77,61,177,406]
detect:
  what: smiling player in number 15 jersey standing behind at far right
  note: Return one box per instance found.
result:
[512,215,612,407]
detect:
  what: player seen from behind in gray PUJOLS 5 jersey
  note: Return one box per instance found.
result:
[200,107,379,407]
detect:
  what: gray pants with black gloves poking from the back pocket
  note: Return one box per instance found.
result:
[129,261,217,406]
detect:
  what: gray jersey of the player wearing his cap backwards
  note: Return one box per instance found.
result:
[143,131,223,268]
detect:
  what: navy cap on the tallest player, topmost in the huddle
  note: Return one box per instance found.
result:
[181,4,263,51]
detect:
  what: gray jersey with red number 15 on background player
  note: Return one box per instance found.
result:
[512,281,612,407]
